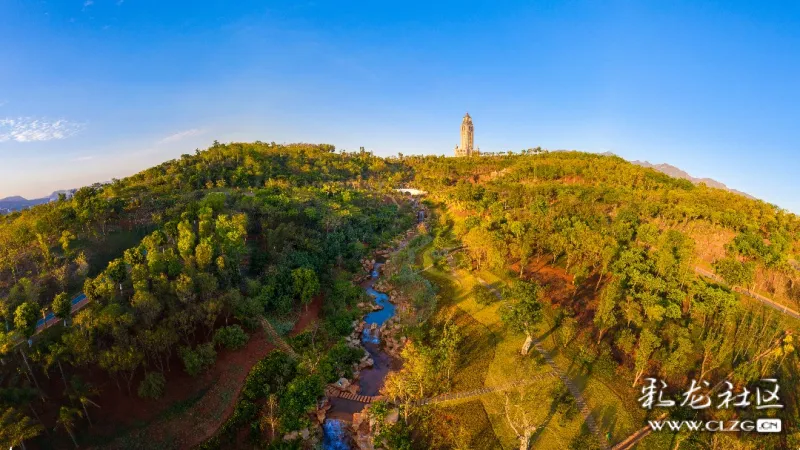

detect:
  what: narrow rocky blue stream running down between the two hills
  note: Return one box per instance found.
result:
[322,262,397,450]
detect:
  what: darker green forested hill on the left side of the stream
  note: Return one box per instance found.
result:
[0,142,414,448]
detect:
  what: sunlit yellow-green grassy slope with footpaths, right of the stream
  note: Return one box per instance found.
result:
[417,237,642,449]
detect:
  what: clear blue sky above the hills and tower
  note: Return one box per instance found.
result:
[0,0,800,212]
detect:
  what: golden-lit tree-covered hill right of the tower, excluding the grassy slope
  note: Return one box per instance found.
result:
[404,152,800,442]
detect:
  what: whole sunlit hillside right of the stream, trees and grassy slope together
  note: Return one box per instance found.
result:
[384,152,800,449]
